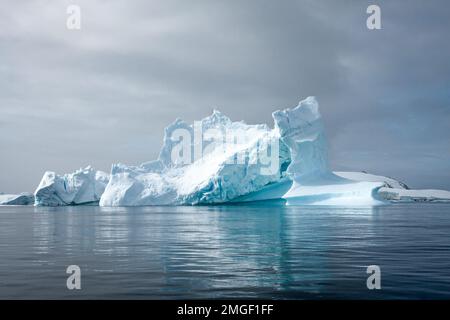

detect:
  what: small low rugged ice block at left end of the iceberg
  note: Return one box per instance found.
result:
[34,167,109,206]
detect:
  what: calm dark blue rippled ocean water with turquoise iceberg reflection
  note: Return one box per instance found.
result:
[0,203,450,299]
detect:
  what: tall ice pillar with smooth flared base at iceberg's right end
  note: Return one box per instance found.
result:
[273,97,384,205]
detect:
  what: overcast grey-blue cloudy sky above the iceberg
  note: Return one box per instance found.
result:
[0,0,450,193]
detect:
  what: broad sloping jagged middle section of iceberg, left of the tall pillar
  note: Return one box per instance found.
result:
[100,111,290,206]
